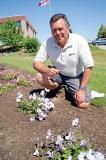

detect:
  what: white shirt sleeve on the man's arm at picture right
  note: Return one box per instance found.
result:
[79,37,94,68]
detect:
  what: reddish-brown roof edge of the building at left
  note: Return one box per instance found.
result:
[0,15,36,33]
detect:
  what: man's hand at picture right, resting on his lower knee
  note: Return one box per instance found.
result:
[75,89,85,104]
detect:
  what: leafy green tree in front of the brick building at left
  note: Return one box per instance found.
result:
[0,18,23,50]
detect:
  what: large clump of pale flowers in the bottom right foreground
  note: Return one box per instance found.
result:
[33,119,105,160]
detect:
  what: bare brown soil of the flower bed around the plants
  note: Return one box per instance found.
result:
[0,64,106,160]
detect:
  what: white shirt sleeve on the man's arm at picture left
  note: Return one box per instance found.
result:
[34,41,48,62]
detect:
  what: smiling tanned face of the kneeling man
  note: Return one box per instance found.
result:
[51,18,69,48]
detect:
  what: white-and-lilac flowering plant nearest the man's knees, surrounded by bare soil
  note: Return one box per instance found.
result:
[16,91,54,121]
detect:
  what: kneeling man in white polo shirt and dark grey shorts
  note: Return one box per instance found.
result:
[33,14,94,108]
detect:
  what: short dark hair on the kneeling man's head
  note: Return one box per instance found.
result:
[50,13,72,33]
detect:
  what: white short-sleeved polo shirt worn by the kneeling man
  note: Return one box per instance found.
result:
[34,33,94,77]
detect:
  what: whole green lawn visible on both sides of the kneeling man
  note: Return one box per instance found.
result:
[0,46,106,106]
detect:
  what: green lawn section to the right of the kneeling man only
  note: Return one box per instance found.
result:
[90,46,106,106]
